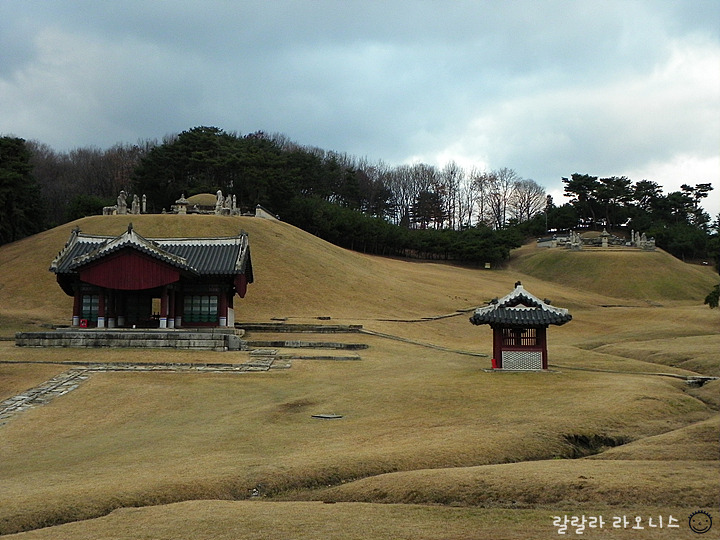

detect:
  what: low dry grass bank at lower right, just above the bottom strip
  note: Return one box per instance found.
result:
[295,459,720,512]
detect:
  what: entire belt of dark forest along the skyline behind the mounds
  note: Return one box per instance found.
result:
[0,126,720,270]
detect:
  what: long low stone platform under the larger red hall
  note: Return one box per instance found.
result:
[15,327,247,351]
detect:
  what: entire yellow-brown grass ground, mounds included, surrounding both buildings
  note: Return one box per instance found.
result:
[0,216,720,539]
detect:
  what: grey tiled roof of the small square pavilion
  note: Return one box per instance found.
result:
[470,281,572,327]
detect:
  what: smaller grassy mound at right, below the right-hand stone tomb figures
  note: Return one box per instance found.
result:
[511,245,718,301]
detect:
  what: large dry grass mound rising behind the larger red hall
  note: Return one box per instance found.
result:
[0,215,580,323]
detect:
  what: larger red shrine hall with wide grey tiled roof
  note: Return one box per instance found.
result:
[50,223,253,328]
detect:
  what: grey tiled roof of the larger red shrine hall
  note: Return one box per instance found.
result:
[50,224,253,283]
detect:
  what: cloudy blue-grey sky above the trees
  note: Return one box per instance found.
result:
[0,0,720,216]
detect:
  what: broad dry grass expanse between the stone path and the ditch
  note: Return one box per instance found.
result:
[0,336,709,532]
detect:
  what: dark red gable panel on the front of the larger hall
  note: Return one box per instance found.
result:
[80,249,180,291]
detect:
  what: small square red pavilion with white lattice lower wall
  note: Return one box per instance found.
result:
[470,281,572,370]
